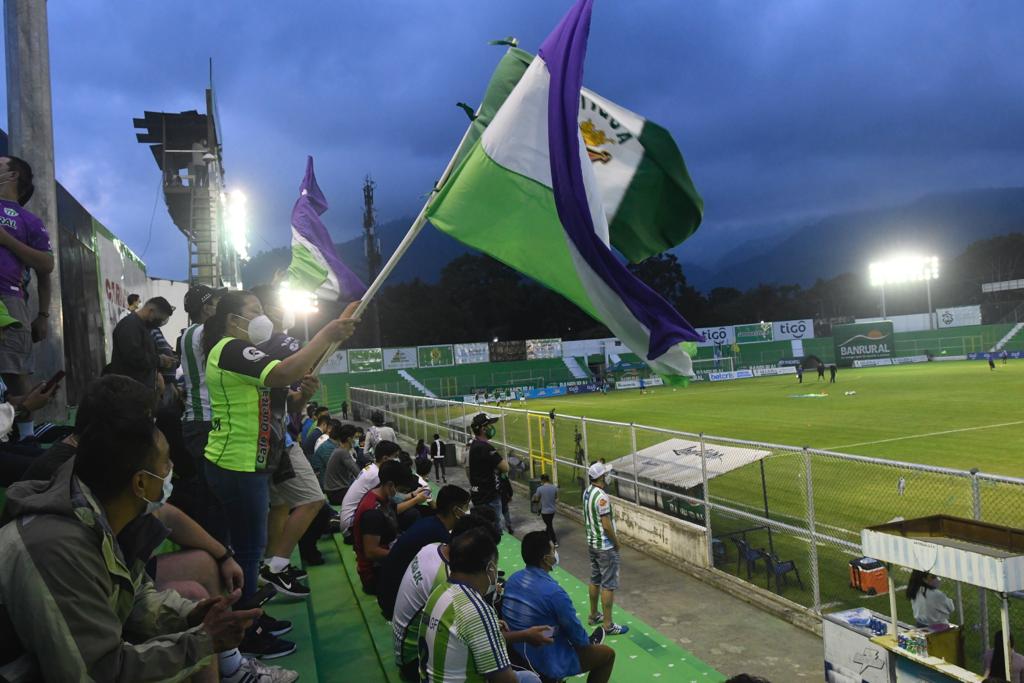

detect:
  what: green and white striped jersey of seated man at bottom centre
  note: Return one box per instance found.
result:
[420,581,510,683]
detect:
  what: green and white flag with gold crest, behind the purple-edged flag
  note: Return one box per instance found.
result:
[463,47,703,263]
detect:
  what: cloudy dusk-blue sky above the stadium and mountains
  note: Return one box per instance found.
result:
[0,0,1024,278]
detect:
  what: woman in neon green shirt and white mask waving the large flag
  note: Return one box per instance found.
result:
[203,291,355,597]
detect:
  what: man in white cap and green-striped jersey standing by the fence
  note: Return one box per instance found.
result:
[583,463,630,636]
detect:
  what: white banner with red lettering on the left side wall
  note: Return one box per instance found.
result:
[95,220,148,358]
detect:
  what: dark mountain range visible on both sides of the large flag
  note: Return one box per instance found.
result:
[243,187,1024,292]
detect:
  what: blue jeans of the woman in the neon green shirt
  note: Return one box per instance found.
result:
[206,461,270,597]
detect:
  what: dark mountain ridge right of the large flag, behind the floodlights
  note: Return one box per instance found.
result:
[680,187,1024,292]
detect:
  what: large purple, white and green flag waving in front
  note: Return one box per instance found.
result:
[428,0,701,381]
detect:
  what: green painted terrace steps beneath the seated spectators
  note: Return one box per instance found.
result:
[267,535,725,683]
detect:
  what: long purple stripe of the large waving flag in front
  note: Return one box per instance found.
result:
[538,0,703,360]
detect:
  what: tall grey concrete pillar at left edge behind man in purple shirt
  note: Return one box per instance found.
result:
[4,0,68,420]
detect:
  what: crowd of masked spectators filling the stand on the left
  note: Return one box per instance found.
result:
[0,157,770,683]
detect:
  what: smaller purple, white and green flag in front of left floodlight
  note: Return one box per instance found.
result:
[288,157,367,301]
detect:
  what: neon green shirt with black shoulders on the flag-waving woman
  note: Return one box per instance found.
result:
[206,337,281,472]
